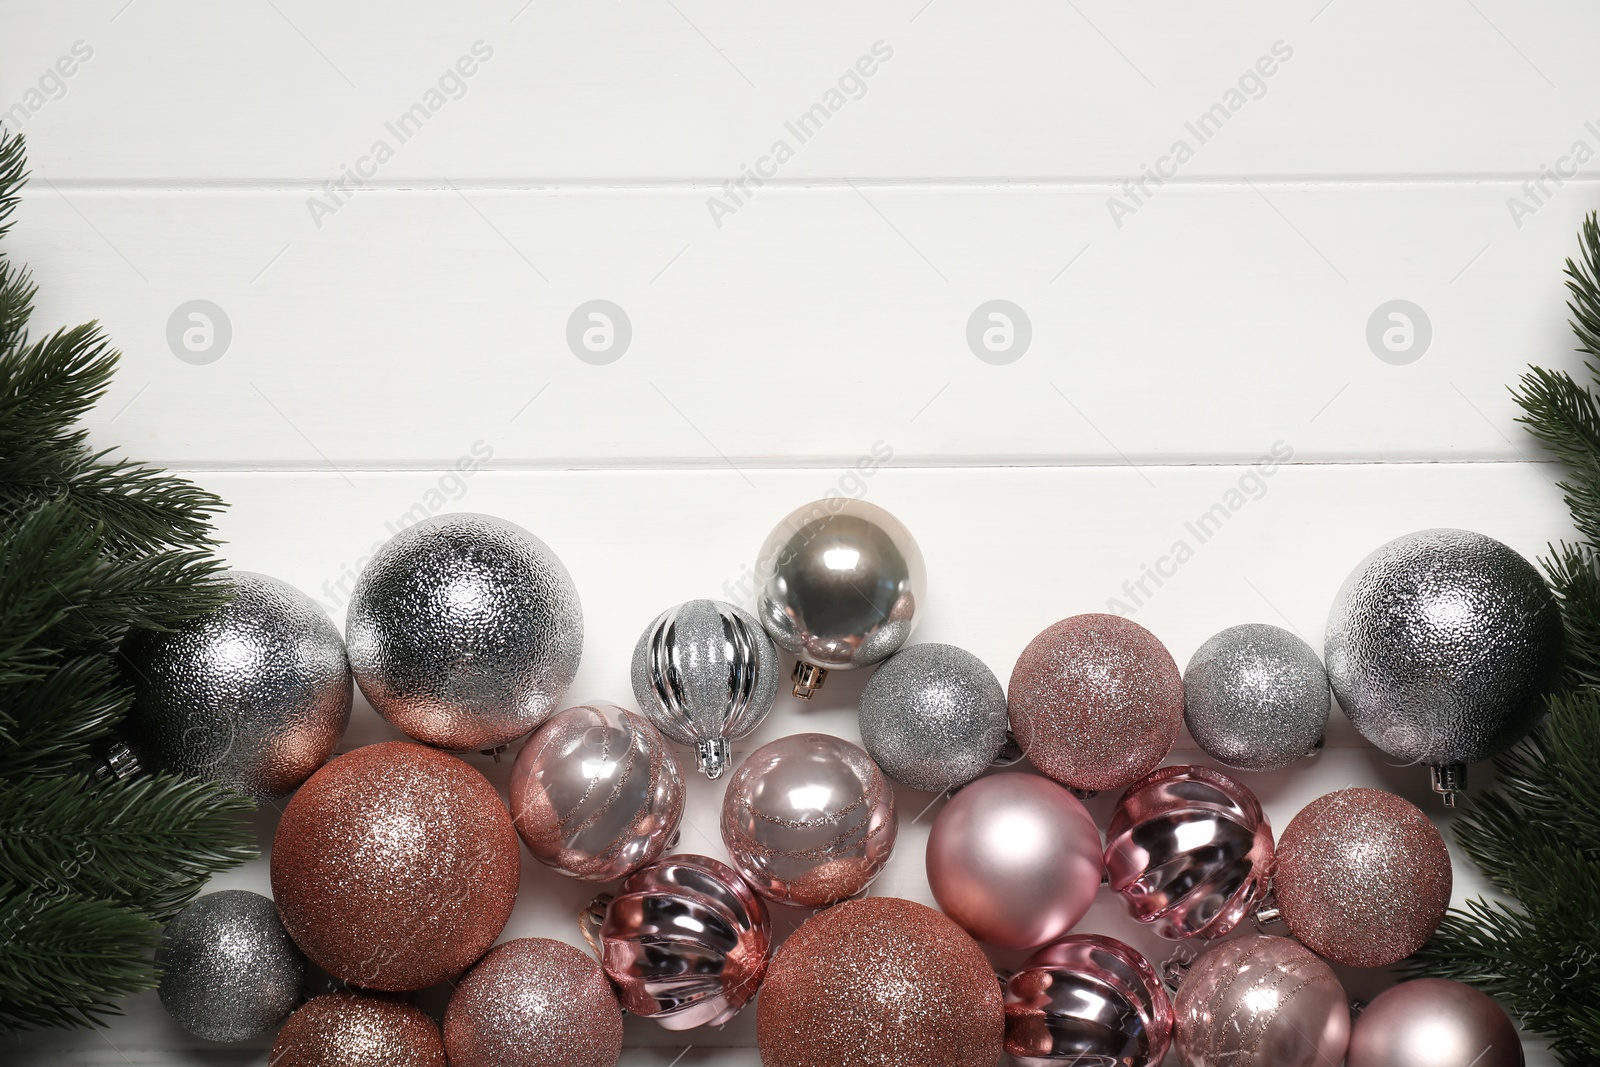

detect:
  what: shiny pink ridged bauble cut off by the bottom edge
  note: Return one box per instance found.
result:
[1005,934,1173,1067]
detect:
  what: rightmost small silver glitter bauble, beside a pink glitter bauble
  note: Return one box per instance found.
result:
[1184,622,1333,771]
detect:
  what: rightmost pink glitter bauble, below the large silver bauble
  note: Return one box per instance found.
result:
[1272,789,1451,966]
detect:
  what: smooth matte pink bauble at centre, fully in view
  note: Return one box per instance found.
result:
[925,773,1101,949]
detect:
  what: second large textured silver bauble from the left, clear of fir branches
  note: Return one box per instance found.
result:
[346,514,584,750]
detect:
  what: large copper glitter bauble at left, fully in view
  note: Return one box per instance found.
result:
[272,741,522,990]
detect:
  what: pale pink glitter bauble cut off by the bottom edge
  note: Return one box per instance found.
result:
[445,937,622,1067]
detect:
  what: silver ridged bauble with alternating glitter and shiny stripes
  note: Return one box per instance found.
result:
[634,600,778,777]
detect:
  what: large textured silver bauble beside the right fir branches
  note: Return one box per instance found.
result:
[1325,530,1562,801]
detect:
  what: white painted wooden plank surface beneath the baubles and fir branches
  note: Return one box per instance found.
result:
[0,0,1600,1067]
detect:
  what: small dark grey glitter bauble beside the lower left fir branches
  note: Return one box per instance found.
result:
[155,889,306,1041]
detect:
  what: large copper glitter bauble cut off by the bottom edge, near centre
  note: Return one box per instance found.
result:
[757,897,1005,1067]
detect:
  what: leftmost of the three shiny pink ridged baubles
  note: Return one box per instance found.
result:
[600,854,773,1030]
